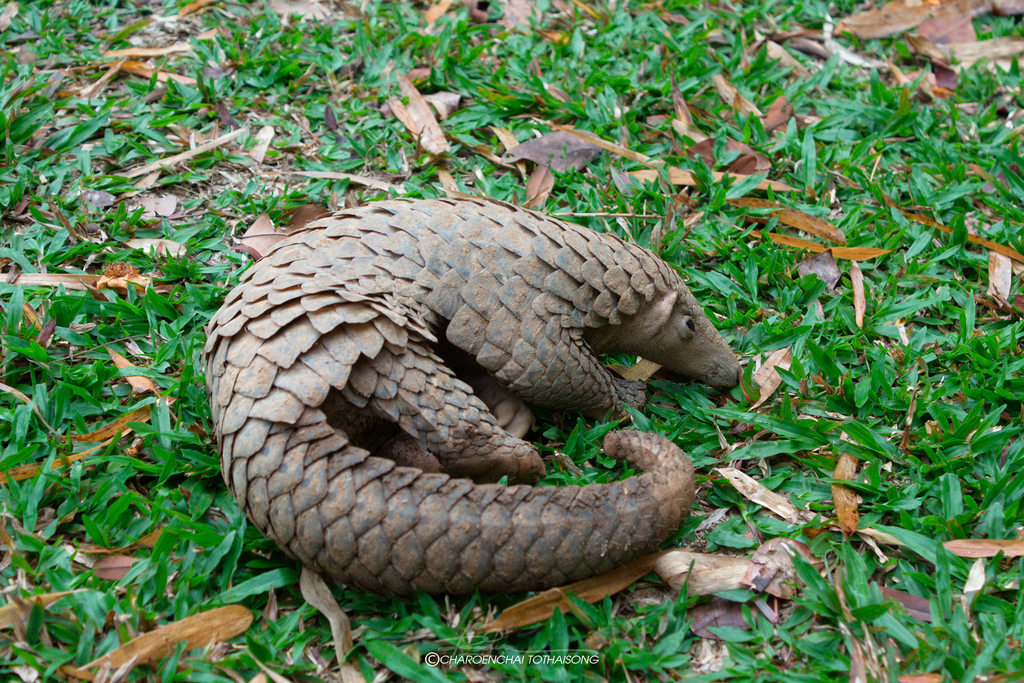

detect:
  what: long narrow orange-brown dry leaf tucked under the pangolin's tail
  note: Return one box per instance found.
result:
[480,553,663,633]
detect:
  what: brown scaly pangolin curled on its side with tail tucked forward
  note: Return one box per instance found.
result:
[205,199,739,595]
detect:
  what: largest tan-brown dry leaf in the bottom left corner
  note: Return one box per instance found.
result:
[60,605,253,680]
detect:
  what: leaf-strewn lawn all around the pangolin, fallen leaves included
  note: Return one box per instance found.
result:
[0,0,1024,683]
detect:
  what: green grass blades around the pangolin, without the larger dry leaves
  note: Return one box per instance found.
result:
[0,0,1024,681]
